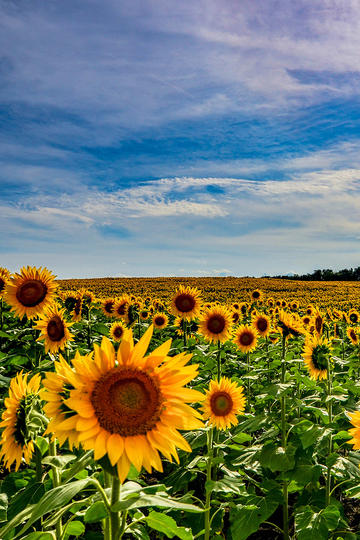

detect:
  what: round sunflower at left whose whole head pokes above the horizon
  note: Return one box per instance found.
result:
[4,266,57,319]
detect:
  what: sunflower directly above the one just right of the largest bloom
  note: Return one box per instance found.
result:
[199,306,232,343]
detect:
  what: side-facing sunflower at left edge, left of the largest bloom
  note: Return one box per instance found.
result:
[0,372,41,471]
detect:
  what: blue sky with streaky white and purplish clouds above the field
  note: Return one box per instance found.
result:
[0,0,360,277]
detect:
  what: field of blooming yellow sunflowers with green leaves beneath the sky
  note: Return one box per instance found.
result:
[0,267,360,540]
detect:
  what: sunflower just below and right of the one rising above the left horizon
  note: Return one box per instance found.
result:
[35,304,74,353]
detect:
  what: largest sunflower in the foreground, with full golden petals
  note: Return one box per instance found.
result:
[47,326,203,482]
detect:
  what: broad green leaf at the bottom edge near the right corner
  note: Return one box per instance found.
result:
[295,505,340,540]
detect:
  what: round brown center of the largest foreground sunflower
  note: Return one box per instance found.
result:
[91,367,164,437]
